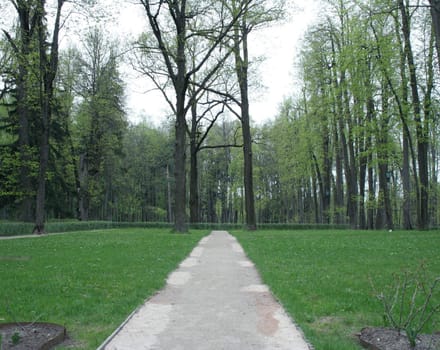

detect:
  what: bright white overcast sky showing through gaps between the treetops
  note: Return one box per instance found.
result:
[113,0,319,124]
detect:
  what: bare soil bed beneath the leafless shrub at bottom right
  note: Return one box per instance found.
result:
[359,327,440,350]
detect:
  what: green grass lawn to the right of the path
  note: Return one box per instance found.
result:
[232,230,440,350]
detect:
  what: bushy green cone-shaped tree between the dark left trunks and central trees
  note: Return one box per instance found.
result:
[72,28,127,220]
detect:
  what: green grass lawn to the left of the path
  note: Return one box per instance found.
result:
[0,228,208,349]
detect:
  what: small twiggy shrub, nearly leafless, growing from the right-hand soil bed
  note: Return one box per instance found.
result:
[373,264,440,347]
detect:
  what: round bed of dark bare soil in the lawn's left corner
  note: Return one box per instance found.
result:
[0,322,66,350]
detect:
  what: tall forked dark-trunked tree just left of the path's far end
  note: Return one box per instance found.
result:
[139,0,252,233]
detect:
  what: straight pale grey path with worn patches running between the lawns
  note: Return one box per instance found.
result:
[99,231,311,350]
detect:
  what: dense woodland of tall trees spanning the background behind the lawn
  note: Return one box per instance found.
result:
[0,0,440,232]
